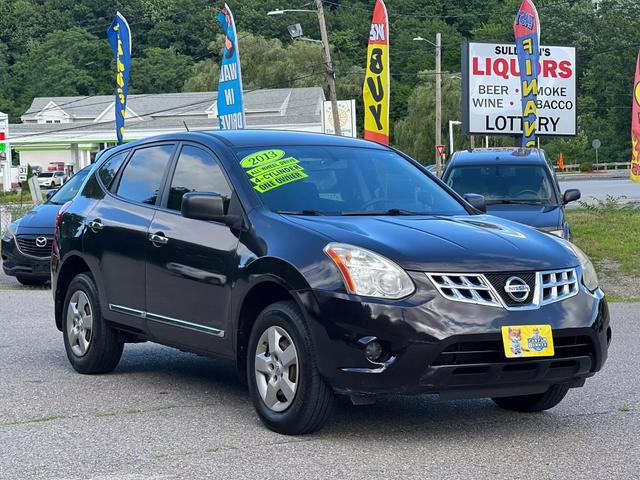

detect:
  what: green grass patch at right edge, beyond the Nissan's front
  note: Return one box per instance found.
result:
[567,204,640,301]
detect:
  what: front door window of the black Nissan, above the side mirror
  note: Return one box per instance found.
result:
[167,145,231,211]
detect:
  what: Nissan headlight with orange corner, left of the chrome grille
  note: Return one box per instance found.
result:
[324,243,416,300]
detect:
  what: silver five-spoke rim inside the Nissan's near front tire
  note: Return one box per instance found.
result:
[255,326,299,412]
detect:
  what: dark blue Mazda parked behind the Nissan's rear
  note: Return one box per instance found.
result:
[1,167,91,286]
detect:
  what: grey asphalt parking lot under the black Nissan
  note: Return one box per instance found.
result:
[0,274,640,480]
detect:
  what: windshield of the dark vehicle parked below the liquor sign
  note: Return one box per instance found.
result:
[446,165,558,205]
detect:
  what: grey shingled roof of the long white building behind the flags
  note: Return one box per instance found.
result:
[10,87,325,145]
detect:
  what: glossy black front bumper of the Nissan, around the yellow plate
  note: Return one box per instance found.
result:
[298,275,611,399]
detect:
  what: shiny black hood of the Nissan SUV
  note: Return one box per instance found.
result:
[288,215,579,273]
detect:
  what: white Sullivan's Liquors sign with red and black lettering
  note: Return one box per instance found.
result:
[462,42,577,136]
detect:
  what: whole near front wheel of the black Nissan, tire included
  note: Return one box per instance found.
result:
[247,301,334,435]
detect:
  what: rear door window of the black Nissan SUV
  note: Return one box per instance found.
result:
[116,145,174,205]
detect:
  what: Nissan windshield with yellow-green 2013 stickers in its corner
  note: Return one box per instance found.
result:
[236,146,467,215]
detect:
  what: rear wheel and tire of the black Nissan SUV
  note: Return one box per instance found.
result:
[62,273,124,374]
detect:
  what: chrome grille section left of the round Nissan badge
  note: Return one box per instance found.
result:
[427,273,502,307]
